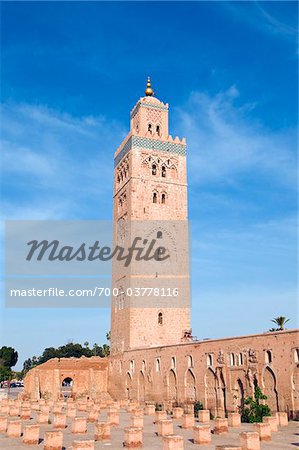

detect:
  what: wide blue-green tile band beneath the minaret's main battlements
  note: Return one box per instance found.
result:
[114,136,186,167]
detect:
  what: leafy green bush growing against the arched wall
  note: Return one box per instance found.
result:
[240,386,271,423]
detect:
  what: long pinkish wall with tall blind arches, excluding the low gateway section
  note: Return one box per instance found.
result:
[108,330,299,416]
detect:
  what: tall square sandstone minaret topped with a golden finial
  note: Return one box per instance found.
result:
[111,79,190,354]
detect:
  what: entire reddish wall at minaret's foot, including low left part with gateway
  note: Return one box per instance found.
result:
[24,330,299,417]
